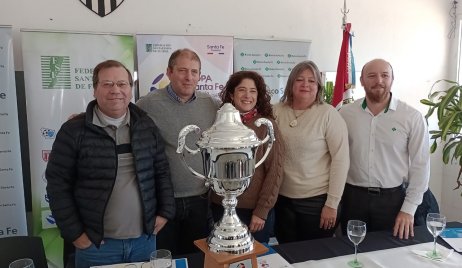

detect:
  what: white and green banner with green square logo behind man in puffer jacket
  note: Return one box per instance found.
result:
[22,31,134,267]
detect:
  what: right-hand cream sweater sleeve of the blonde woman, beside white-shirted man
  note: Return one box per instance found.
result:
[325,109,350,209]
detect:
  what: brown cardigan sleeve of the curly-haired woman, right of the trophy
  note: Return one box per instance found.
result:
[253,120,284,219]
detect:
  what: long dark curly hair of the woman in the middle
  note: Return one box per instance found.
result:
[220,71,274,119]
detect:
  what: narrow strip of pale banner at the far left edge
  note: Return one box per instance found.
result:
[0,26,27,238]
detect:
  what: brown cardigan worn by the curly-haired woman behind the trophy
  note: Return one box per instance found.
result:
[211,115,284,220]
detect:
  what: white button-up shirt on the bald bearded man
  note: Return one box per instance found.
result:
[340,96,430,215]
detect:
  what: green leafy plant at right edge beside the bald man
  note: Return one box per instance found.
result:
[420,79,462,195]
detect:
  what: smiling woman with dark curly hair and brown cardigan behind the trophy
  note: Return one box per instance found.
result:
[211,71,284,243]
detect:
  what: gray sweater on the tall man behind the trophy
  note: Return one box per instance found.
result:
[136,88,218,198]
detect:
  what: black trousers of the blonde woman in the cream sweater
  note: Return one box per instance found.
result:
[275,194,339,243]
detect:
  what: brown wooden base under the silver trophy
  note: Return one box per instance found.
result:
[194,238,268,268]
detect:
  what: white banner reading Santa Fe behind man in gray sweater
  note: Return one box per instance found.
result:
[136,34,233,98]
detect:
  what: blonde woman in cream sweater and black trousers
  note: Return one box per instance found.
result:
[274,61,349,243]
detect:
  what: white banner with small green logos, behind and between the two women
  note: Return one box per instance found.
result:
[234,39,311,103]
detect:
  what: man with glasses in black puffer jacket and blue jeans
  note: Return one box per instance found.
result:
[46,60,175,268]
